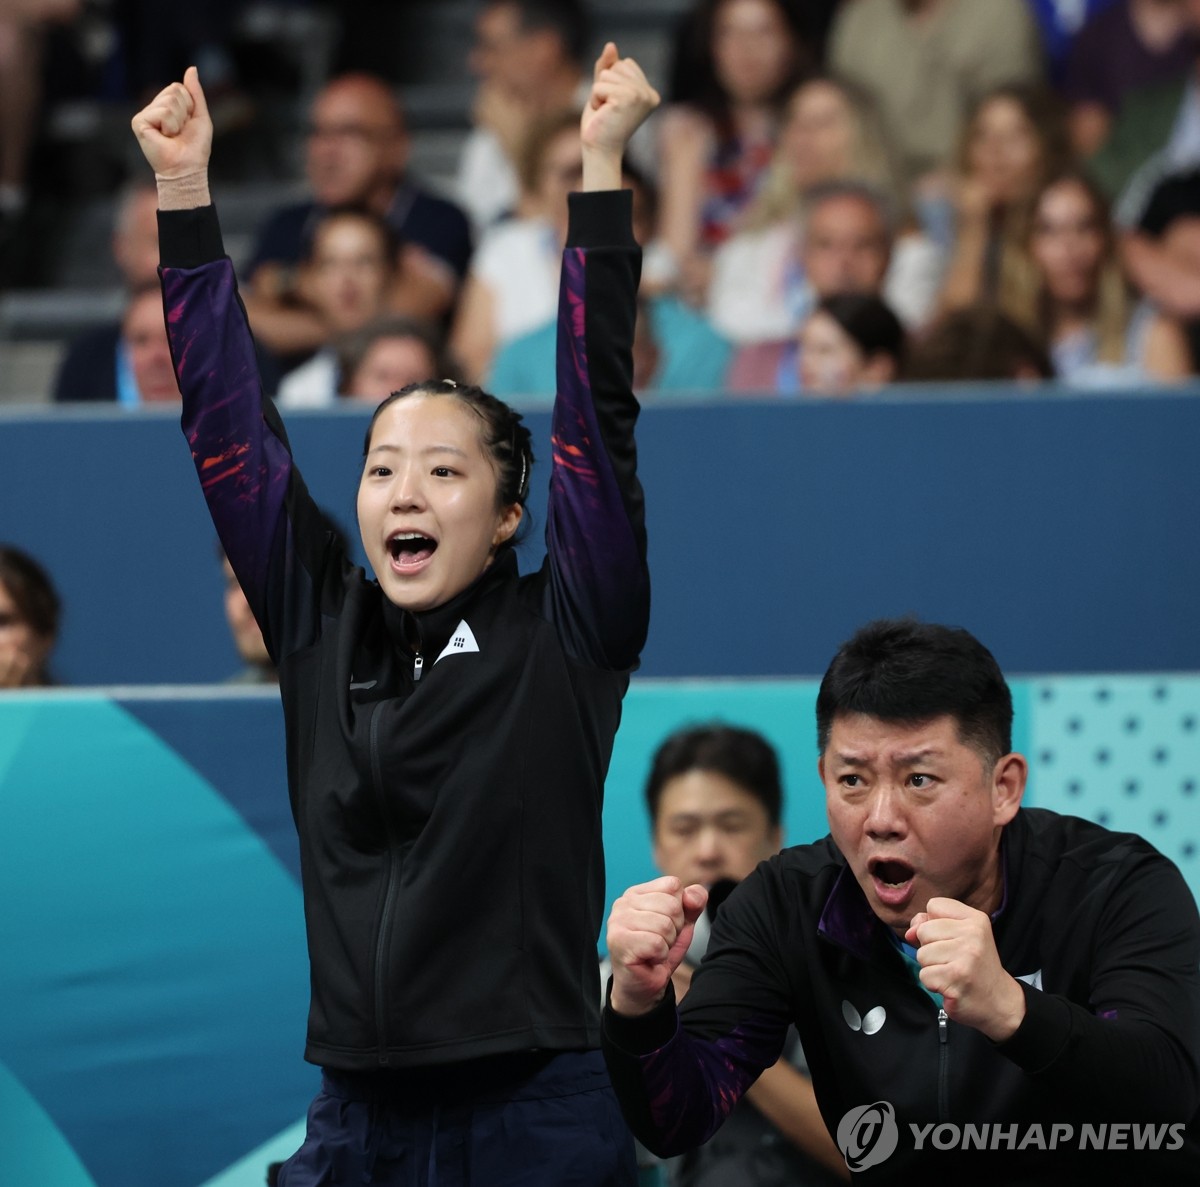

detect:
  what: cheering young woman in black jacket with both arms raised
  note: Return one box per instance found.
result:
[133,44,658,1187]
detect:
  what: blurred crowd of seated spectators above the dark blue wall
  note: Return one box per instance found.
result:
[7,0,1200,408]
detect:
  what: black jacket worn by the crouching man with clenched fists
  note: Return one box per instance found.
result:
[604,808,1200,1187]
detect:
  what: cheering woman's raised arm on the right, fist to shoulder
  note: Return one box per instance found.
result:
[546,42,659,670]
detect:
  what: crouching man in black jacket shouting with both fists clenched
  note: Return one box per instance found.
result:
[604,621,1200,1185]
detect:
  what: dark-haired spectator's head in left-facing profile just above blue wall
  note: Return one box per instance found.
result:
[799,293,905,396]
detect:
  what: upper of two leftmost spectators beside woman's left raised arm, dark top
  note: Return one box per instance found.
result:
[54,180,161,402]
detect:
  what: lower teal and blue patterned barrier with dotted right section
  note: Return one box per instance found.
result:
[0,676,1200,1187]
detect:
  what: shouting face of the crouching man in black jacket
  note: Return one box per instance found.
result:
[818,714,1027,936]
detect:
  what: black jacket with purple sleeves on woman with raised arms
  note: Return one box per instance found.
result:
[160,193,649,1069]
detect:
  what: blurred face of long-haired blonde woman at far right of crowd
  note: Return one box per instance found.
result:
[1030,180,1108,305]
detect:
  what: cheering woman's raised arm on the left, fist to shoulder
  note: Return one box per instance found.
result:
[133,66,342,664]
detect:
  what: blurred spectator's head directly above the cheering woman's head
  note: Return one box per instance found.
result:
[336,316,455,404]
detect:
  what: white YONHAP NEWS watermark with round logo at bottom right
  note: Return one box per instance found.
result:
[836,1101,1187,1170]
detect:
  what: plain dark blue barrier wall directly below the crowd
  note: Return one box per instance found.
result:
[0,389,1200,684]
